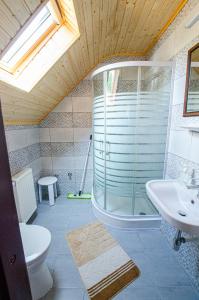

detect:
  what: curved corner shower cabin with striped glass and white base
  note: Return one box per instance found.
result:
[92,61,172,228]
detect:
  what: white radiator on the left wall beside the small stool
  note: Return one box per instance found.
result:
[12,168,37,223]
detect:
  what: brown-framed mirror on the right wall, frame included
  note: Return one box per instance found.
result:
[183,43,199,117]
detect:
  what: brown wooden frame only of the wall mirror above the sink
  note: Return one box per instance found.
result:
[183,43,199,117]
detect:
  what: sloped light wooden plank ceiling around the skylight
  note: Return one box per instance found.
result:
[0,0,187,124]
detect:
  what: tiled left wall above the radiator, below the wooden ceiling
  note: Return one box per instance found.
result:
[5,126,41,200]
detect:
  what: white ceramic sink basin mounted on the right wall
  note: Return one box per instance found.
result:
[146,180,199,235]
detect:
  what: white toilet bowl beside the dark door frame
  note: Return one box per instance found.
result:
[19,223,53,300]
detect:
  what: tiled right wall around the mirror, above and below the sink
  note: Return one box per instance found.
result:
[152,0,199,289]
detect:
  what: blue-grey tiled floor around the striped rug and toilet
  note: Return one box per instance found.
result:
[34,197,199,300]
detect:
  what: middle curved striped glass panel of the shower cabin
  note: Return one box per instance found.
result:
[105,67,138,215]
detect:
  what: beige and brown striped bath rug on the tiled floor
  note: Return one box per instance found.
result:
[66,222,139,300]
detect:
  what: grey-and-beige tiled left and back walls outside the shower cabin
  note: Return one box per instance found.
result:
[5,57,145,199]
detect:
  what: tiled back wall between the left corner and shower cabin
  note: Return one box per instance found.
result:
[40,80,93,194]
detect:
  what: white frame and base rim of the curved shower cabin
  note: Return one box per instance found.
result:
[91,61,174,229]
